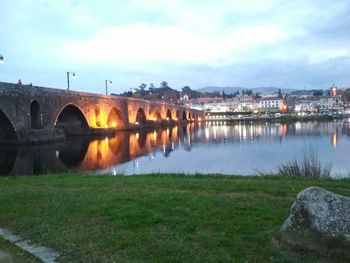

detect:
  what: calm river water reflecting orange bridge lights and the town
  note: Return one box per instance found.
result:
[0,119,350,177]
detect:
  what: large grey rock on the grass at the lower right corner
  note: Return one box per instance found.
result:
[280,187,350,254]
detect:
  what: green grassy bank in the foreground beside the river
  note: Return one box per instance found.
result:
[0,175,350,262]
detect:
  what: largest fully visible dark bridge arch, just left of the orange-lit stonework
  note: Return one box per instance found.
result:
[55,104,89,135]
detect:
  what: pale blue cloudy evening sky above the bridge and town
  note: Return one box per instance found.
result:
[0,0,350,93]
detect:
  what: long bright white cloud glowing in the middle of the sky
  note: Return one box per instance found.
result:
[64,24,287,69]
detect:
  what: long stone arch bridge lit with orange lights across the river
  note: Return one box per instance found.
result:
[0,82,203,143]
